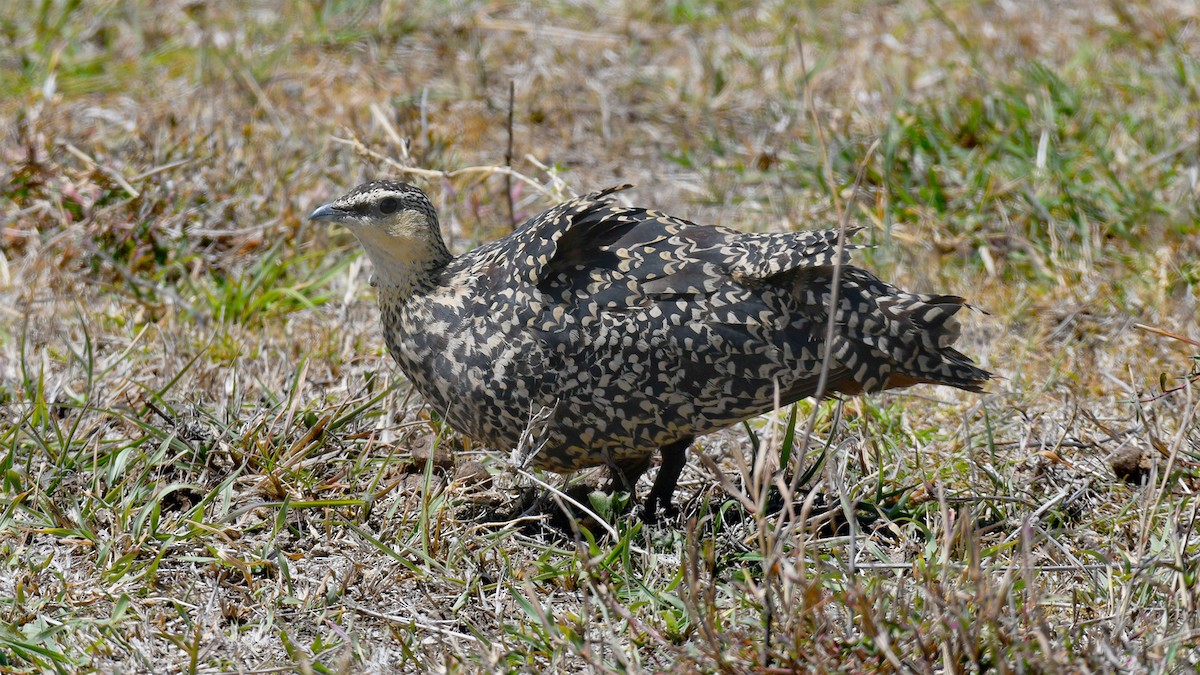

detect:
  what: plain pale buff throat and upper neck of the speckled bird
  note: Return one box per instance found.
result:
[355,225,452,300]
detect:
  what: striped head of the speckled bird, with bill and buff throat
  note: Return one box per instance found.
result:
[308,180,450,285]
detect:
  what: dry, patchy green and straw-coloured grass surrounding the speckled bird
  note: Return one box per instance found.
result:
[0,0,1200,673]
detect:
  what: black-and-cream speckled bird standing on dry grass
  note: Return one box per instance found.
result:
[310,180,992,522]
